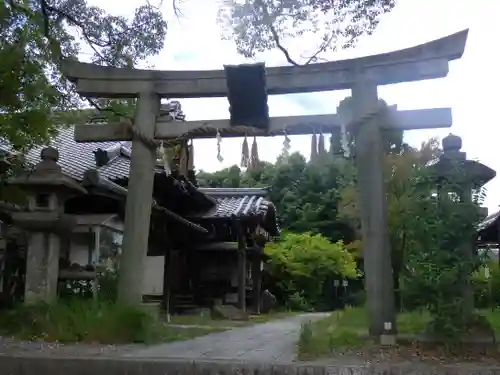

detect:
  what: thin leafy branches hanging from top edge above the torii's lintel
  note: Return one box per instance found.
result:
[219,0,396,65]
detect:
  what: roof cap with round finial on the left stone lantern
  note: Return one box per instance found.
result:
[9,146,87,194]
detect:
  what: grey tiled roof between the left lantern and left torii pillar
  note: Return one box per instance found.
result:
[26,127,130,181]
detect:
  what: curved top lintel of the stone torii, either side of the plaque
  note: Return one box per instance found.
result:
[61,29,469,98]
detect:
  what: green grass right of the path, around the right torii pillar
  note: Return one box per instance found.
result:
[297,308,500,360]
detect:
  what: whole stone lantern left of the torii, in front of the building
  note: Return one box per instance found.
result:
[9,147,86,303]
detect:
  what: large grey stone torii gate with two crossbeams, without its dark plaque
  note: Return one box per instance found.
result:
[63,30,468,337]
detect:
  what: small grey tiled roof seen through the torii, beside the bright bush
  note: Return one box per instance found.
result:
[194,188,271,218]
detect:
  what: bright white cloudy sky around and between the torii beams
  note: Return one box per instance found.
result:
[89,0,500,213]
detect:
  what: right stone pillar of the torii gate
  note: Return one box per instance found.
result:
[351,77,396,337]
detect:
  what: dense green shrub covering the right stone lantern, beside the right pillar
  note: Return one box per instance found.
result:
[400,164,481,339]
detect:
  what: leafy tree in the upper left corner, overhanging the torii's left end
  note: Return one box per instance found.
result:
[0,0,171,148]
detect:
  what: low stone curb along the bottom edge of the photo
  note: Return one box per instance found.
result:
[0,355,500,375]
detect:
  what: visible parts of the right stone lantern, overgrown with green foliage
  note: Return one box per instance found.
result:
[431,133,496,318]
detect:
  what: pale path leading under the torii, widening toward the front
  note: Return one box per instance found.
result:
[123,313,327,361]
